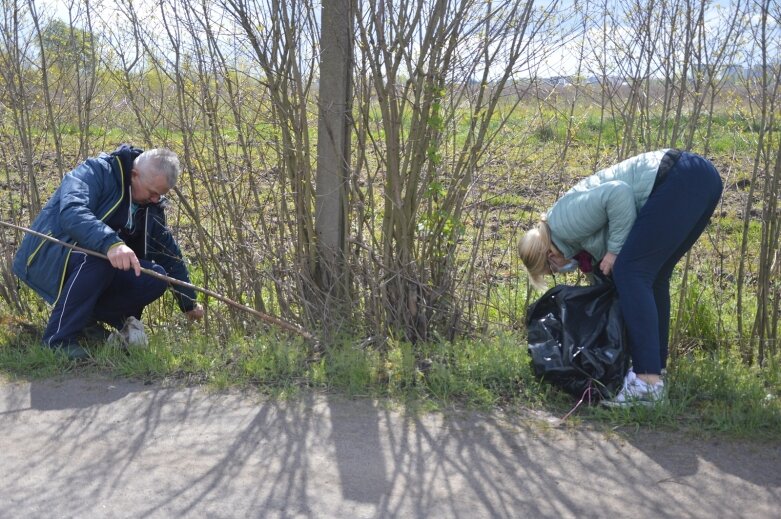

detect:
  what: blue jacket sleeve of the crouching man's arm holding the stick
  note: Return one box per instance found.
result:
[59,159,122,254]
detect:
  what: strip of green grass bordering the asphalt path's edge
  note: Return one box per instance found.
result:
[0,314,781,440]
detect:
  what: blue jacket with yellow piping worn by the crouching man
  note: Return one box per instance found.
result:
[13,145,195,312]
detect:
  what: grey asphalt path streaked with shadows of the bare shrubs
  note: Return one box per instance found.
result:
[0,379,781,519]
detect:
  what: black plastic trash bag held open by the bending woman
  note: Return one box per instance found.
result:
[526,282,630,399]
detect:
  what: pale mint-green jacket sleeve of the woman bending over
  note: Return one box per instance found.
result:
[549,180,637,254]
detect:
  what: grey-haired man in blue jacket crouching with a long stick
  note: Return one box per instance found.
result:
[13,145,203,359]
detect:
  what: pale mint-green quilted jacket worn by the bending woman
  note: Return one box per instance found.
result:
[547,149,667,261]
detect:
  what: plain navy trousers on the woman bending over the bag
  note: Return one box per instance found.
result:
[613,152,723,374]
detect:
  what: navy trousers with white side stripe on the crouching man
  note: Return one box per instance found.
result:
[43,252,168,346]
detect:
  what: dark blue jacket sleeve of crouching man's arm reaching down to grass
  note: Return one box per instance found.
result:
[146,208,197,312]
